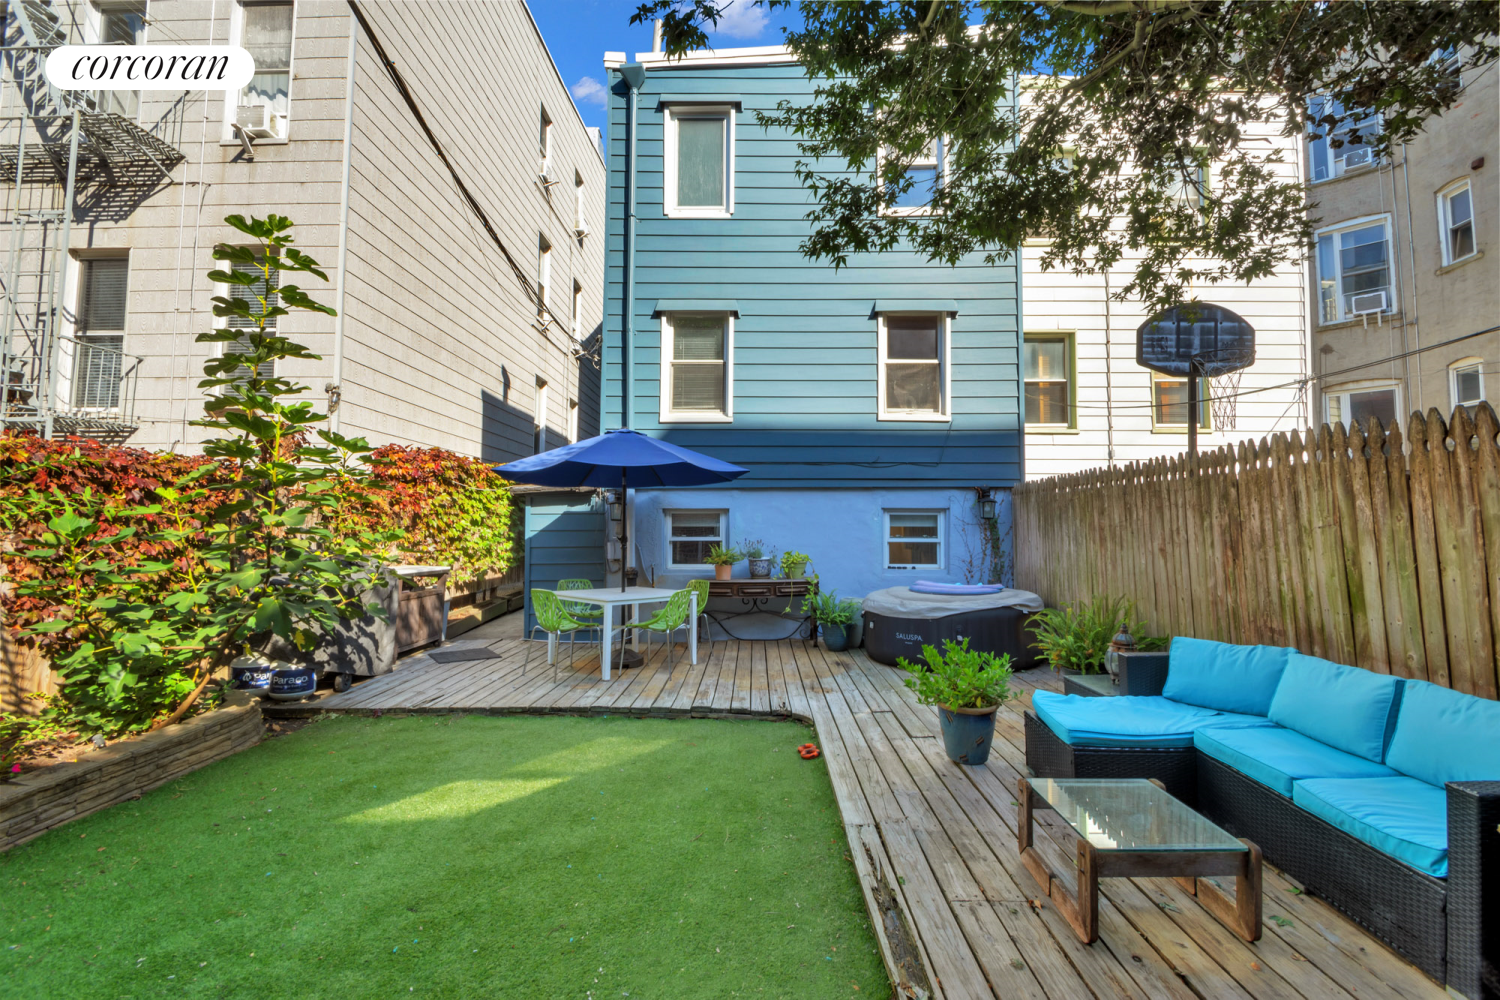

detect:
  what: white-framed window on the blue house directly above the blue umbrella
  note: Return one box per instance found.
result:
[660,312,735,423]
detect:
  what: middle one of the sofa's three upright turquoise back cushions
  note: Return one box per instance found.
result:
[1268,652,1401,761]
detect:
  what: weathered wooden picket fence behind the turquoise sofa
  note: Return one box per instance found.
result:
[1013,403,1500,699]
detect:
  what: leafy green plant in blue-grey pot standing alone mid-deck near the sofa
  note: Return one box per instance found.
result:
[896,639,1016,765]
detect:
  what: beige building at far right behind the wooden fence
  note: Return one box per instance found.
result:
[1308,53,1500,424]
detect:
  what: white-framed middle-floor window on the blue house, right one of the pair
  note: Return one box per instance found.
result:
[876,312,950,421]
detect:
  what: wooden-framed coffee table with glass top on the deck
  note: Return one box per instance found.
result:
[1016,778,1260,945]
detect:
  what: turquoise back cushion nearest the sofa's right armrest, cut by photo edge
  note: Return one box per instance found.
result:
[1386,681,1500,786]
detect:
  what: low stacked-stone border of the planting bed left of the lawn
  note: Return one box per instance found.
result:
[0,699,261,852]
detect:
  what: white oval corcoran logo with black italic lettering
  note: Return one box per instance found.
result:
[47,45,255,90]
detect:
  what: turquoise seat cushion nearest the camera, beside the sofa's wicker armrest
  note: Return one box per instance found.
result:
[1292,775,1448,879]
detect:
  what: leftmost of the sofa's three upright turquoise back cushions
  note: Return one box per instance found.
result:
[1161,636,1295,715]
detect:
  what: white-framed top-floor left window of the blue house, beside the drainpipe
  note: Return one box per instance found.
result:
[662,105,735,219]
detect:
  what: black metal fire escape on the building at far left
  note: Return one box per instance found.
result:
[0,0,186,441]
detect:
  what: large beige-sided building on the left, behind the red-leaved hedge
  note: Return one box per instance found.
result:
[0,0,605,459]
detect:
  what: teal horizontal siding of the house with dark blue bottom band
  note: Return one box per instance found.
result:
[602,64,1022,489]
